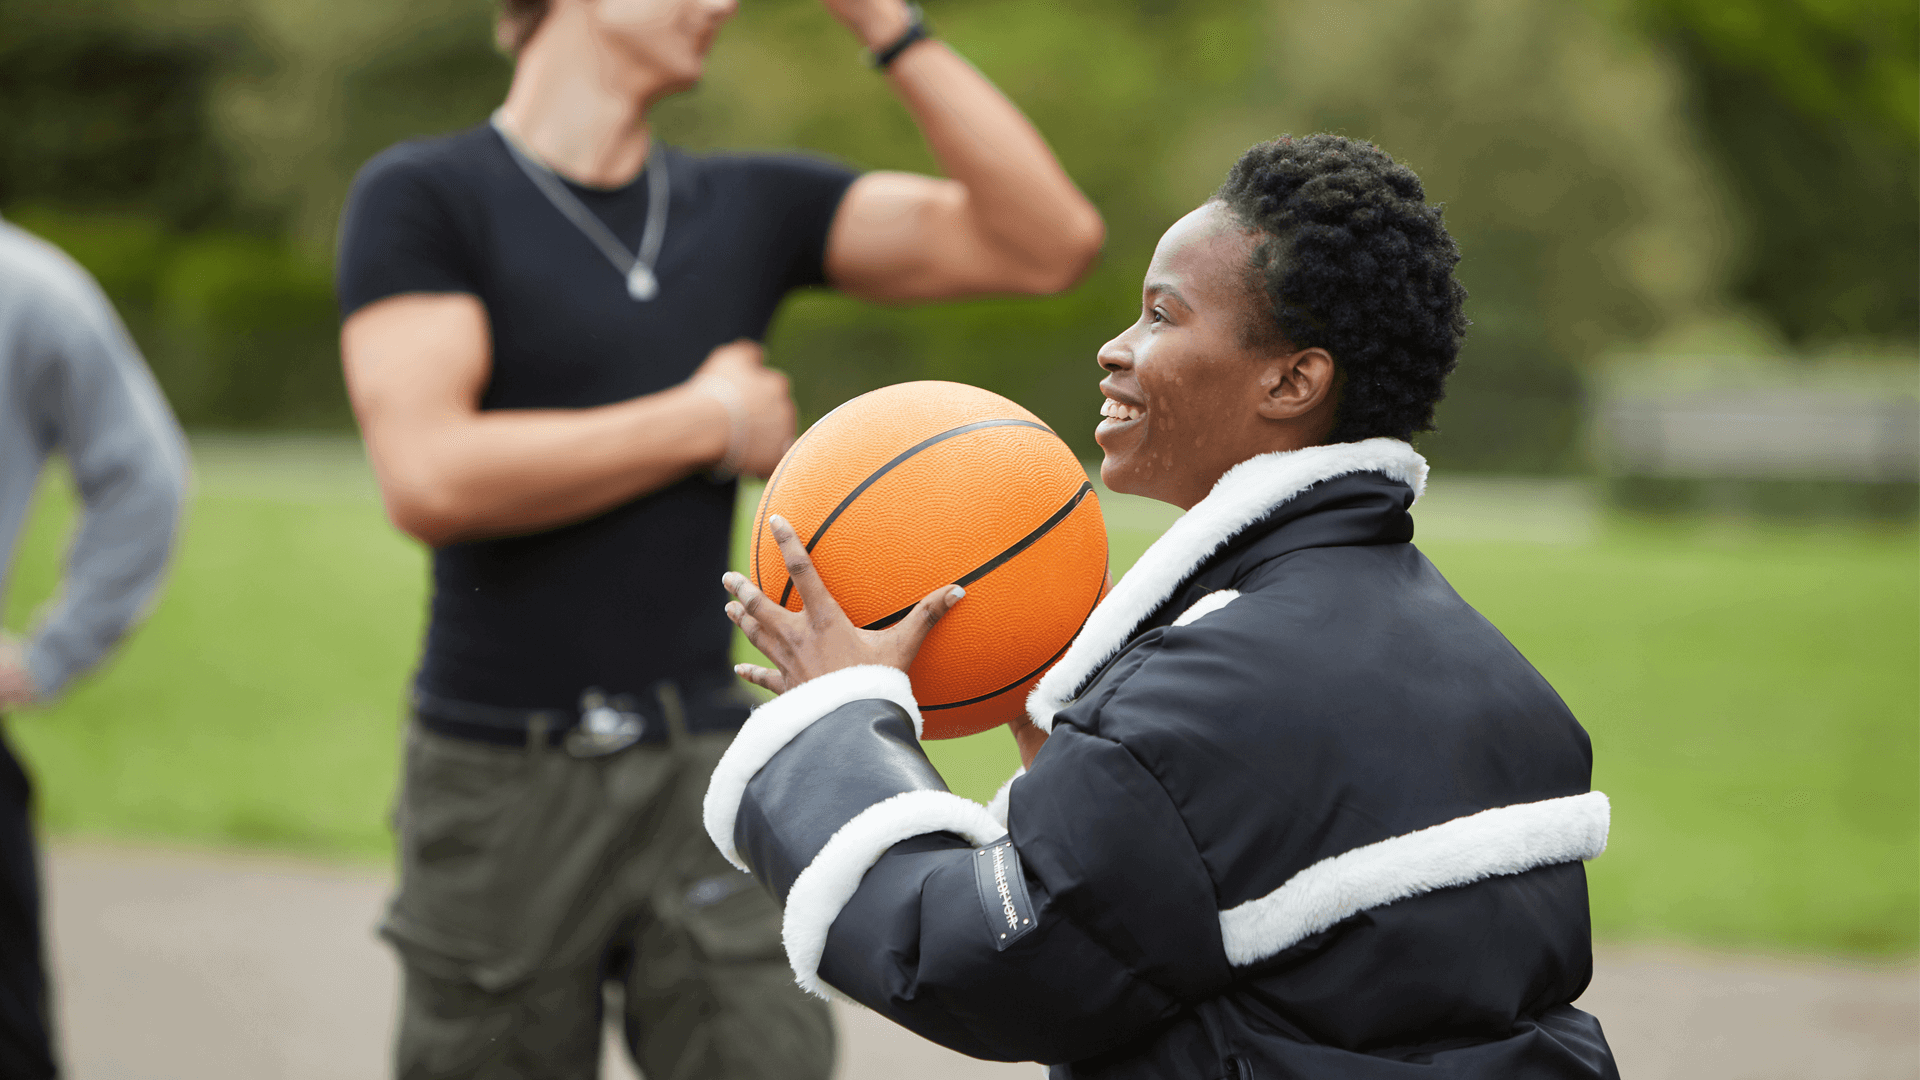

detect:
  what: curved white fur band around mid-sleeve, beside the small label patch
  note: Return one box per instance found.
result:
[780,790,1006,997]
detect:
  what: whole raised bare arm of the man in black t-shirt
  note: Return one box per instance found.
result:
[826,0,1106,302]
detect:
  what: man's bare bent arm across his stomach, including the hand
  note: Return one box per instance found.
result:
[340,292,795,548]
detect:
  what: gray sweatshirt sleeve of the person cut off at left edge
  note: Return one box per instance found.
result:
[8,234,188,700]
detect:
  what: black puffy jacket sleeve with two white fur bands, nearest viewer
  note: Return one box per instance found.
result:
[707,667,1229,1063]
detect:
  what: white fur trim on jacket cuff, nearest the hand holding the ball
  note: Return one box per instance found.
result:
[703,663,920,871]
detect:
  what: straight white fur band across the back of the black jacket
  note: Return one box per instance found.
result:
[1219,792,1611,965]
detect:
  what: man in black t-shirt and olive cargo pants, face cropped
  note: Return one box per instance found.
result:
[338,0,1104,1078]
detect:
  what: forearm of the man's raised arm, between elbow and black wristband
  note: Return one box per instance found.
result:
[887,40,1106,279]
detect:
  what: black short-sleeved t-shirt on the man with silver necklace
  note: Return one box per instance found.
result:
[338,125,854,709]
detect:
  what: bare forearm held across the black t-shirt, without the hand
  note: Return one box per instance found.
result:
[367,386,730,548]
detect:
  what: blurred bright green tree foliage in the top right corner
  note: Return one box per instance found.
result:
[1634,0,1920,348]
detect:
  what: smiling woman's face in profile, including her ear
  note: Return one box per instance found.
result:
[1094,202,1332,507]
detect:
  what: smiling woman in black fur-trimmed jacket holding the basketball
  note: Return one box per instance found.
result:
[705,135,1619,1080]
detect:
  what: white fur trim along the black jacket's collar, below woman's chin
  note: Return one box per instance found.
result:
[1027,438,1427,732]
